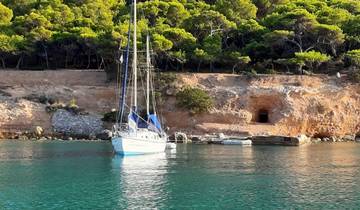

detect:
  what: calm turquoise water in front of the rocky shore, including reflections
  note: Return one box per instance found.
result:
[0,141,360,209]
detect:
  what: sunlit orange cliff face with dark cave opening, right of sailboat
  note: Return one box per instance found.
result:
[164,74,360,137]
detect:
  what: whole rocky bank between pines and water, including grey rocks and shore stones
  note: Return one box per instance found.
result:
[0,70,360,145]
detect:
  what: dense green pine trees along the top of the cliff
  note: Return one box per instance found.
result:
[0,0,360,76]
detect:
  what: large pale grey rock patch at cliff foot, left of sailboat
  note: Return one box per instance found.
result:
[51,109,103,136]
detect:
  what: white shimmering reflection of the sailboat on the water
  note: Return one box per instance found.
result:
[113,153,168,209]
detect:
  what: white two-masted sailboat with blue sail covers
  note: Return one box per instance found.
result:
[112,0,167,155]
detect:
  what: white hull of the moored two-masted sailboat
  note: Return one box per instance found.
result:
[112,132,166,155]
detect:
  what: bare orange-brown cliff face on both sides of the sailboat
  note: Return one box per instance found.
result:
[0,71,360,137]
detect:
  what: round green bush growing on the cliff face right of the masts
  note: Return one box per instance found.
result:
[176,87,214,114]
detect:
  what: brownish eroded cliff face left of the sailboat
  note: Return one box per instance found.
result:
[0,70,116,134]
